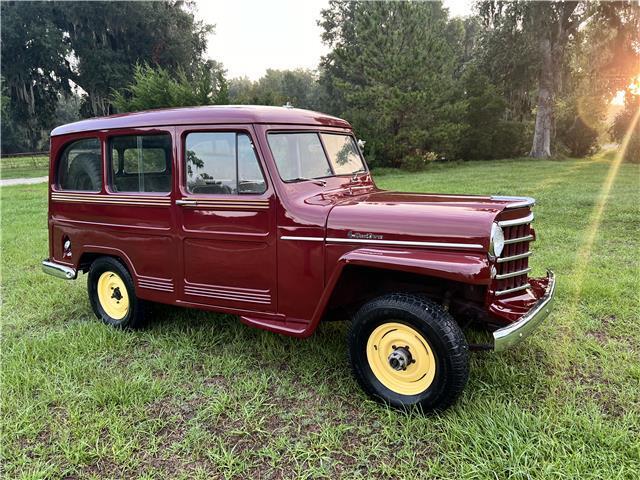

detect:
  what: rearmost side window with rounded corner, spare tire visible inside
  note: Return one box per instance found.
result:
[58,138,102,192]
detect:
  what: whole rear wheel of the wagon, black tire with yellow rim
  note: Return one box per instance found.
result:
[87,257,146,328]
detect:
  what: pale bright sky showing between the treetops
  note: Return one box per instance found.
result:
[196,0,471,80]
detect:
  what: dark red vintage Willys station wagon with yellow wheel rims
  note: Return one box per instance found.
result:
[43,106,555,410]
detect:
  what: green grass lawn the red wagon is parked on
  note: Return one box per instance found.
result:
[1,149,640,479]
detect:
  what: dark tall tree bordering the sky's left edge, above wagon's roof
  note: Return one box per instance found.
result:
[60,0,213,115]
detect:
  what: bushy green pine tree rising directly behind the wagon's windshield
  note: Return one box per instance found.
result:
[319,1,464,166]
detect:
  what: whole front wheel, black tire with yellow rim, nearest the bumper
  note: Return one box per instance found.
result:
[348,294,469,411]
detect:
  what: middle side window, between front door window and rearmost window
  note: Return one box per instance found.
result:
[109,134,172,193]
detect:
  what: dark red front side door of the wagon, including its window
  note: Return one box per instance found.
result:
[176,126,277,312]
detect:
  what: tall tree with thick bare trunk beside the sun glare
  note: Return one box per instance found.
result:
[478,1,637,157]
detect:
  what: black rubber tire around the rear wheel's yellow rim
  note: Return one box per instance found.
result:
[87,257,148,329]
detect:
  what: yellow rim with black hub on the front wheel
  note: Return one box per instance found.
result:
[367,322,436,395]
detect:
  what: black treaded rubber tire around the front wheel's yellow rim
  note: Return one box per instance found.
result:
[348,293,469,412]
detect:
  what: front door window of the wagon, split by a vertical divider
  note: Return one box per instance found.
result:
[185,132,267,195]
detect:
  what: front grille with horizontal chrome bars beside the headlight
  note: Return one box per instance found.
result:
[493,215,534,296]
